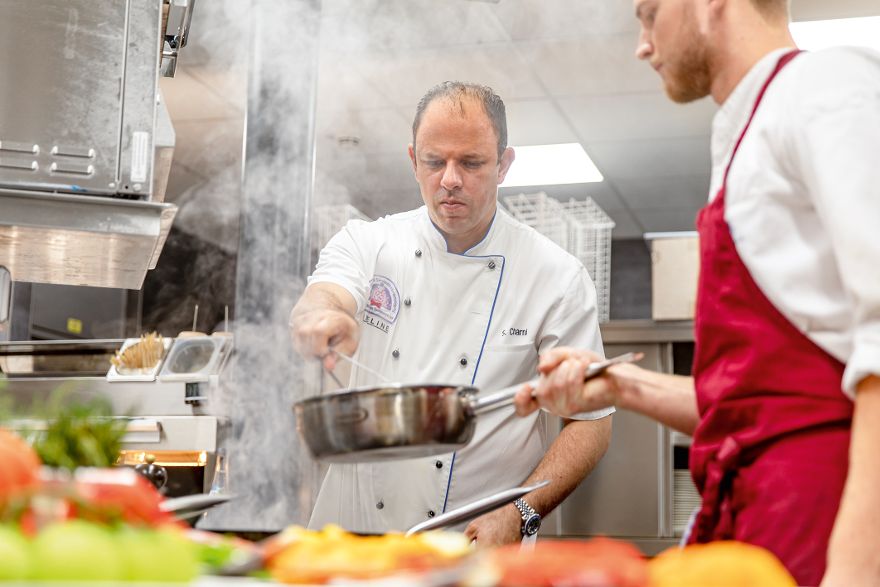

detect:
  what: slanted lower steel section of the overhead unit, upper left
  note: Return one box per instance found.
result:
[0,189,177,289]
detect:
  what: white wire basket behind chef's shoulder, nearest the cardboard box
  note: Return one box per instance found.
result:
[562,197,614,322]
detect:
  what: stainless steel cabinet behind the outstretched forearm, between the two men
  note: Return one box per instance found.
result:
[547,320,699,555]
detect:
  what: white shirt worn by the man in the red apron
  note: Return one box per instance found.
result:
[710,47,880,397]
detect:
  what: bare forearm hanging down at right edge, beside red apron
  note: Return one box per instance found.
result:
[822,376,880,587]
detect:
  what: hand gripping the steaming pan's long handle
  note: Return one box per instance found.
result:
[514,347,629,416]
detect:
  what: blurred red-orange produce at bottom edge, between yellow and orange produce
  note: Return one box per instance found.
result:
[475,538,648,587]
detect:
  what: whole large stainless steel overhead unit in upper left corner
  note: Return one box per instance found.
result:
[0,0,192,289]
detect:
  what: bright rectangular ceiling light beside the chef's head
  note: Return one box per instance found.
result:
[501,143,604,187]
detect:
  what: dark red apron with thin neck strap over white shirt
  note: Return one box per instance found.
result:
[690,51,853,585]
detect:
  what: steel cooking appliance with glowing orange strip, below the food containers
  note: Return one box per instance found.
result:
[0,337,232,497]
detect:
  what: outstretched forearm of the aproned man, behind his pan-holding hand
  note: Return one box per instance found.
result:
[614,365,700,435]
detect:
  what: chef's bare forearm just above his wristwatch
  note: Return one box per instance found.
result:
[525,416,611,515]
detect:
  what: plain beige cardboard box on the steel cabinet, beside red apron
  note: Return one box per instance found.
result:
[645,232,700,320]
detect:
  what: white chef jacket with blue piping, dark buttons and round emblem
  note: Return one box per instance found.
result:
[309,207,613,532]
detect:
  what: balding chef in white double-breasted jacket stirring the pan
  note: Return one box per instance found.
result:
[291,82,613,545]
